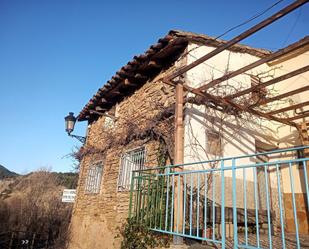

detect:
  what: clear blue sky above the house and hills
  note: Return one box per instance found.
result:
[0,0,309,173]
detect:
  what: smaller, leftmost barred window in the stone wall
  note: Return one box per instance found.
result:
[85,162,103,194]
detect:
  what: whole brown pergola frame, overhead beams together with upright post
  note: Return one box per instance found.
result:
[166,0,309,239]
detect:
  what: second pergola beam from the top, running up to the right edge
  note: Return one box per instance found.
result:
[198,36,309,91]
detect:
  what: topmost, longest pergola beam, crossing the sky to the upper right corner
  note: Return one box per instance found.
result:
[166,0,308,80]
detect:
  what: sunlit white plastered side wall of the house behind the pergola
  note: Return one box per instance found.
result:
[184,44,309,206]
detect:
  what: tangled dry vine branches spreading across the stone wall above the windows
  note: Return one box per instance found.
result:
[72,97,175,165]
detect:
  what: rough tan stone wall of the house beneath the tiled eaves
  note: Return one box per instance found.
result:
[69,72,175,249]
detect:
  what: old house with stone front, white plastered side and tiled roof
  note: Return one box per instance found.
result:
[70,31,309,249]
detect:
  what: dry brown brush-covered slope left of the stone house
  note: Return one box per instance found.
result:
[0,170,78,249]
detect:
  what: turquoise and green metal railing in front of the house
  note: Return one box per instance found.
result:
[129,147,309,248]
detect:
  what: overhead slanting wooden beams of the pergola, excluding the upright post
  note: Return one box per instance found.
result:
[162,0,309,128]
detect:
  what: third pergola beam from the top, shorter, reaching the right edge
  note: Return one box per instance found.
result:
[226,65,309,99]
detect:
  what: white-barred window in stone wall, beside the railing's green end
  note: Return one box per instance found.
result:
[118,147,146,191]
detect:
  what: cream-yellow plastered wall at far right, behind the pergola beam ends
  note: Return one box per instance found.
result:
[270,46,309,193]
